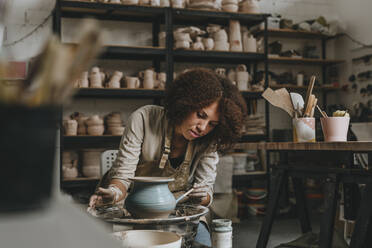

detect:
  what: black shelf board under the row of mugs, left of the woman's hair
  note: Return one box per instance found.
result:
[75,88,164,99]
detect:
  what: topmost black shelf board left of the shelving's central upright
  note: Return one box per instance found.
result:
[58,1,165,22]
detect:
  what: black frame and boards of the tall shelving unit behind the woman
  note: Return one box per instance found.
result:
[53,0,269,188]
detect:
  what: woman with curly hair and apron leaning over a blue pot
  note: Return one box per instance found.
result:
[90,69,246,246]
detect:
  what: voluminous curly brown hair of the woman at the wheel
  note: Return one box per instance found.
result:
[165,68,247,152]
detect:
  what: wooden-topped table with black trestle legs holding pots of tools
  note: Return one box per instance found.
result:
[236,141,372,248]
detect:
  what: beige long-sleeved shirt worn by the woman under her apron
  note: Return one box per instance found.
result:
[104,105,218,202]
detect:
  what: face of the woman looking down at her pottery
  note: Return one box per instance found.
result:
[175,101,219,140]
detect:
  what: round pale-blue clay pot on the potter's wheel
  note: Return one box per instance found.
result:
[125,177,176,219]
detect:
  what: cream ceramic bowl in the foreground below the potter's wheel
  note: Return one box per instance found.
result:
[112,230,182,248]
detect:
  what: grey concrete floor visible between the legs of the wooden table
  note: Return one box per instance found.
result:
[233,217,319,248]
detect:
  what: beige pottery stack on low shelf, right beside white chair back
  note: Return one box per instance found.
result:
[82,149,103,177]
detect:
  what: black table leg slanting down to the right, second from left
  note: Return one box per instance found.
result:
[292,177,311,233]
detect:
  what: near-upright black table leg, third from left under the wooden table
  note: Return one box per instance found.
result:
[319,175,339,248]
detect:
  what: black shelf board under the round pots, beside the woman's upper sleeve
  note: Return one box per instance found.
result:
[62,135,121,150]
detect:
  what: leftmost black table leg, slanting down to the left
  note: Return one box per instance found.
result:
[256,169,288,248]
